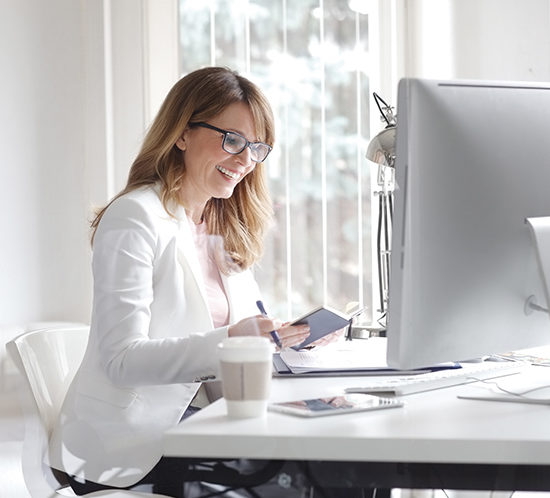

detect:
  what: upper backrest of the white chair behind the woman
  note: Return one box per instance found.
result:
[6,326,90,436]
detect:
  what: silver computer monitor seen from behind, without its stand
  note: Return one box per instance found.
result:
[387,79,550,369]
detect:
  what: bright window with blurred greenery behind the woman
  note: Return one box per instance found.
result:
[179,0,378,321]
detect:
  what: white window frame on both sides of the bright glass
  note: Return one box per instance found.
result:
[99,0,406,322]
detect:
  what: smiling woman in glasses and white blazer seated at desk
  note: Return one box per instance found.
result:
[49,67,309,493]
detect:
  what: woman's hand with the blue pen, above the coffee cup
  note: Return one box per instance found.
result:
[227,315,309,348]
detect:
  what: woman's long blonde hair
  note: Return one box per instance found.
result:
[91,67,275,273]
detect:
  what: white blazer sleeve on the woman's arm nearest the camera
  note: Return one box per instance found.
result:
[90,197,227,386]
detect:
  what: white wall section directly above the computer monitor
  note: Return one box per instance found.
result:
[397,0,550,81]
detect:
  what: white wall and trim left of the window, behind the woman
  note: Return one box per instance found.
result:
[0,0,160,327]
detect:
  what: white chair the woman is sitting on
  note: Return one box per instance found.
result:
[6,326,168,498]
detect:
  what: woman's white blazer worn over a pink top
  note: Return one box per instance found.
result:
[49,187,259,487]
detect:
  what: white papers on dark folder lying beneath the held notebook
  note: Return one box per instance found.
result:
[280,337,427,375]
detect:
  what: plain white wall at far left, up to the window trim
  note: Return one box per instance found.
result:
[0,0,90,324]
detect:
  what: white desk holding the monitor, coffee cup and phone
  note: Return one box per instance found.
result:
[164,367,550,489]
